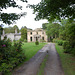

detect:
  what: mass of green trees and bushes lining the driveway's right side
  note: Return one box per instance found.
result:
[42,19,75,55]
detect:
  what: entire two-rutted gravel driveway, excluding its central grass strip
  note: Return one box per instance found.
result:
[13,43,64,75]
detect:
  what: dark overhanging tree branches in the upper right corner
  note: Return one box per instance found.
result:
[29,0,75,21]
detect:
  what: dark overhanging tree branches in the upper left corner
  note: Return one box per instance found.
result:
[0,0,27,25]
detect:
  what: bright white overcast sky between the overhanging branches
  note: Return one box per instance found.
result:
[3,0,47,29]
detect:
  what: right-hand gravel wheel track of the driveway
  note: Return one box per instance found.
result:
[44,43,64,75]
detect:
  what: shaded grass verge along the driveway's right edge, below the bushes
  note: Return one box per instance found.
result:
[56,44,75,75]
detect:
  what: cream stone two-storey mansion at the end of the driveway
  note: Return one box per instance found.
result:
[27,28,47,42]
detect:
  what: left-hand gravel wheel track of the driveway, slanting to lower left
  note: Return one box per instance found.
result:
[13,44,48,75]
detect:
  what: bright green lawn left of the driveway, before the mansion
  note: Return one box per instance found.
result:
[22,43,47,61]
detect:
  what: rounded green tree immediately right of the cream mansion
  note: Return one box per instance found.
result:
[46,23,60,38]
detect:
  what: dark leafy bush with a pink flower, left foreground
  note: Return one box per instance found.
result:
[0,39,25,73]
